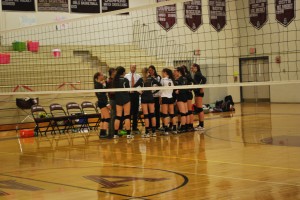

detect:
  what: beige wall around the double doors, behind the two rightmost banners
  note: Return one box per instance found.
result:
[236,0,300,103]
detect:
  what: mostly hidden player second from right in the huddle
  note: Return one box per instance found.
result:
[181,65,194,131]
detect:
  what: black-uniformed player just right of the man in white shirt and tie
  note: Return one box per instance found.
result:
[134,68,161,137]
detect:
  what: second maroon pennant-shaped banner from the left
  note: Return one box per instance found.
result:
[184,0,202,31]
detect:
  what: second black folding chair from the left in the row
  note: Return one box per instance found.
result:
[49,103,72,134]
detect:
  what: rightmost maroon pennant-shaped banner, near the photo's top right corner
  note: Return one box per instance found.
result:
[275,0,296,26]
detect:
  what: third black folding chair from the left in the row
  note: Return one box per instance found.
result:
[66,102,88,132]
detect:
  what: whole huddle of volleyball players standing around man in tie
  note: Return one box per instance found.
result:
[94,64,206,139]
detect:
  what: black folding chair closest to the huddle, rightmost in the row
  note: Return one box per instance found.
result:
[81,101,101,130]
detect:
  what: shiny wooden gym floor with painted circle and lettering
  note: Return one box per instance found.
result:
[0,103,300,200]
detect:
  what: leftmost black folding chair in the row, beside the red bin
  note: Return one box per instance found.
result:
[31,105,53,136]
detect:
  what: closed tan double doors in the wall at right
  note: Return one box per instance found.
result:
[239,56,270,103]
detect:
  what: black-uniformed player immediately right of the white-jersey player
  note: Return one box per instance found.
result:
[174,67,188,133]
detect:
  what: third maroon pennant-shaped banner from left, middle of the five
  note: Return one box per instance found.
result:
[209,0,226,32]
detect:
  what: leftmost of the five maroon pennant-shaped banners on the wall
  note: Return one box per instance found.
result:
[156,0,177,31]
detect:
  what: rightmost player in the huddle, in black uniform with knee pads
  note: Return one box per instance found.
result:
[191,64,206,131]
